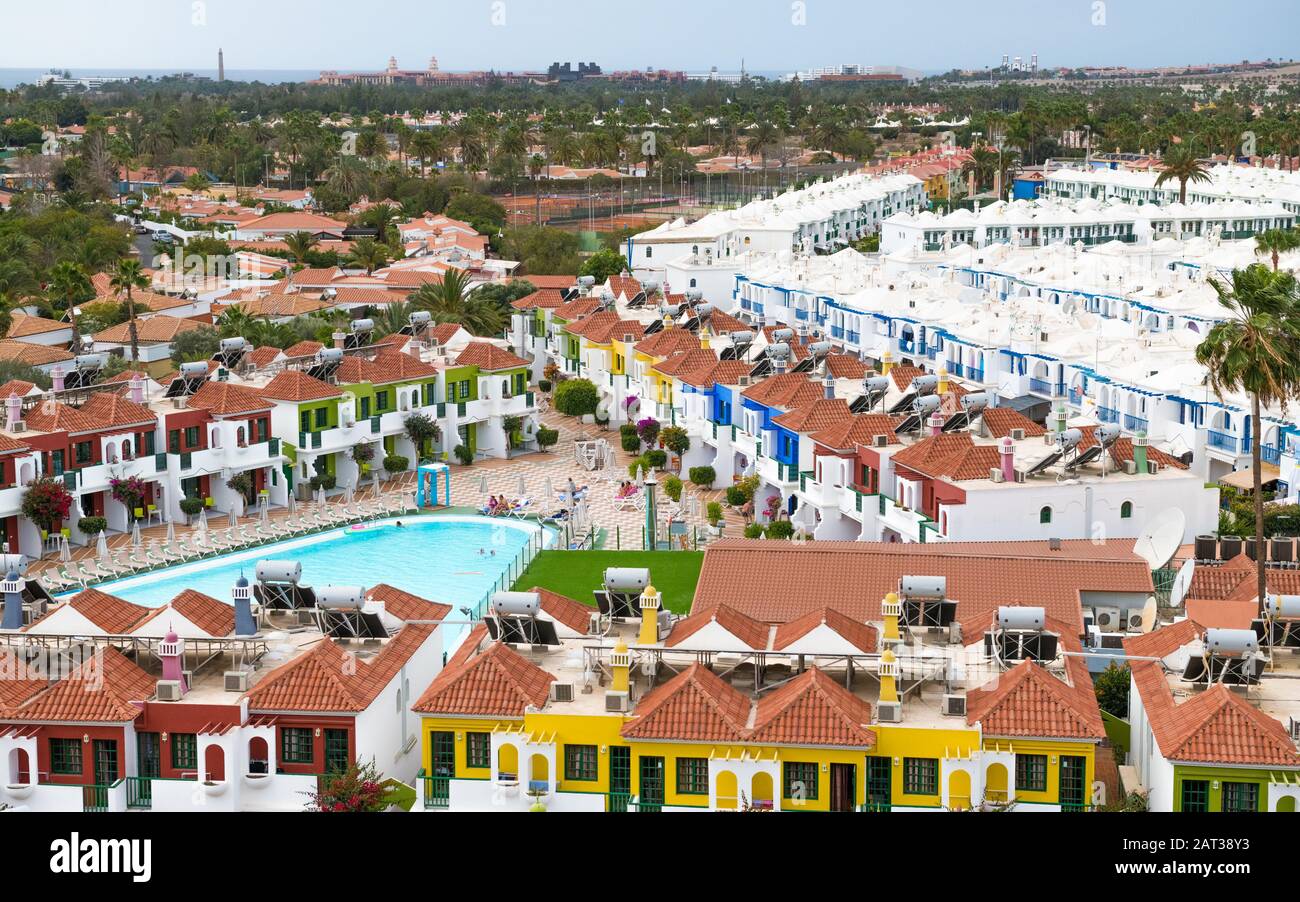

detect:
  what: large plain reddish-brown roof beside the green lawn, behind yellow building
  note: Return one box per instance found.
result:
[696,538,1153,632]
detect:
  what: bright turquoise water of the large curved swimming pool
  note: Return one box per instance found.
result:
[89,516,554,616]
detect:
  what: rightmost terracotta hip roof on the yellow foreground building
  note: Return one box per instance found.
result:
[966,660,1106,740]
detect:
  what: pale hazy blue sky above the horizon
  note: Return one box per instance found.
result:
[10,0,1300,74]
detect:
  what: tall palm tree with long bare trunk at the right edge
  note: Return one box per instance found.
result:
[1196,264,1300,616]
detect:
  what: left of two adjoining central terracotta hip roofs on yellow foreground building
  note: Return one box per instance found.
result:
[620,663,750,742]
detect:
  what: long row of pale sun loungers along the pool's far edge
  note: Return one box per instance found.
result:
[39,493,410,593]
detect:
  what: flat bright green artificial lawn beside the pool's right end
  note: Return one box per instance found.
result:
[514,551,705,613]
